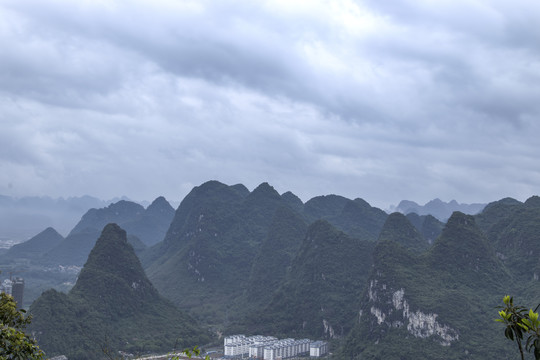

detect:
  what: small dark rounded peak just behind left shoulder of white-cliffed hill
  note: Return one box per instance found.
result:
[379,213,429,252]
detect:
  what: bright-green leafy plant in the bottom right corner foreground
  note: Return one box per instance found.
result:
[495,295,540,360]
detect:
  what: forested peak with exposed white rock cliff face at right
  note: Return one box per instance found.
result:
[340,213,514,360]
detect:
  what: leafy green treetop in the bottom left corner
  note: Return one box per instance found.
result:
[0,293,45,360]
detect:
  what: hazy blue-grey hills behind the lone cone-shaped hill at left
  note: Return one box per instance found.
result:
[0,197,174,307]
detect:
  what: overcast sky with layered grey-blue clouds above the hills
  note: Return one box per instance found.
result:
[0,0,540,208]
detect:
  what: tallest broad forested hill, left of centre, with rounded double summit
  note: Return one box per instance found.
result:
[144,182,292,321]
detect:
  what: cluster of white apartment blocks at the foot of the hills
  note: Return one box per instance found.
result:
[223,335,328,360]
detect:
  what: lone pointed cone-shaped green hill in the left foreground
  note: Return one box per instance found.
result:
[30,224,209,359]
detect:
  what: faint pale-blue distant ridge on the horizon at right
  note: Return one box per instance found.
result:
[392,199,486,222]
